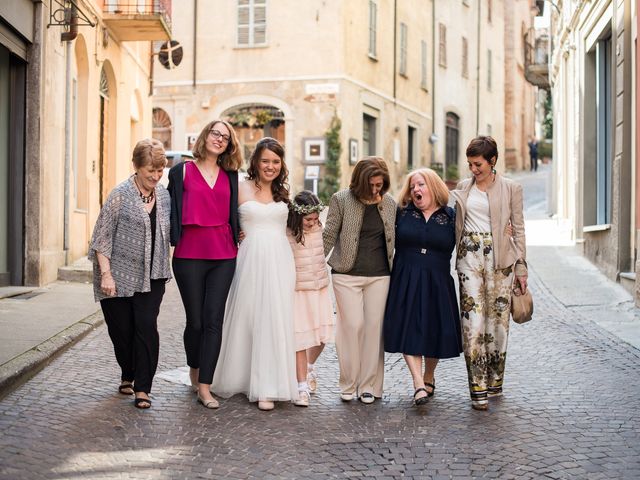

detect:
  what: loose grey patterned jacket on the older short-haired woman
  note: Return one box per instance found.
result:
[89,175,171,302]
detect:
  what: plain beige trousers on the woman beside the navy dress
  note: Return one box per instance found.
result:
[332,273,390,398]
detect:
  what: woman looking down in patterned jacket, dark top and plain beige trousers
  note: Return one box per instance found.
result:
[323,157,396,404]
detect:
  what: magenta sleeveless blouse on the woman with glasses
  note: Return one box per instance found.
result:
[173,162,238,260]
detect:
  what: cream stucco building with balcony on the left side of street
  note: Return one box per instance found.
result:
[0,0,170,285]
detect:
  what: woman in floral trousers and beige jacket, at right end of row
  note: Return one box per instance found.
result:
[452,136,527,410]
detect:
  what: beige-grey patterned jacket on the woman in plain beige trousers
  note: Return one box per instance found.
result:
[322,188,396,273]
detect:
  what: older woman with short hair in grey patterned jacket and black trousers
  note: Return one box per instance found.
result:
[89,139,171,408]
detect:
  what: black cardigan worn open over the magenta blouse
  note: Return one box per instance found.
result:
[167,160,239,247]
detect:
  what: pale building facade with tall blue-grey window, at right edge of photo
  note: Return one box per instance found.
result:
[550,0,639,299]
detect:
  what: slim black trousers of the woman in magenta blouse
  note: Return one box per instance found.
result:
[173,257,236,385]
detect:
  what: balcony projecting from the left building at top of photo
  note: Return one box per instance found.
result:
[102,0,171,41]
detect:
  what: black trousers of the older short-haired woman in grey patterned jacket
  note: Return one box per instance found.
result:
[100,280,166,393]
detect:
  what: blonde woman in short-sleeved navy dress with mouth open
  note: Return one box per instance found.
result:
[384,168,462,405]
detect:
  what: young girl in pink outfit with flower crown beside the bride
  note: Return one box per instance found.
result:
[287,190,335,407]
